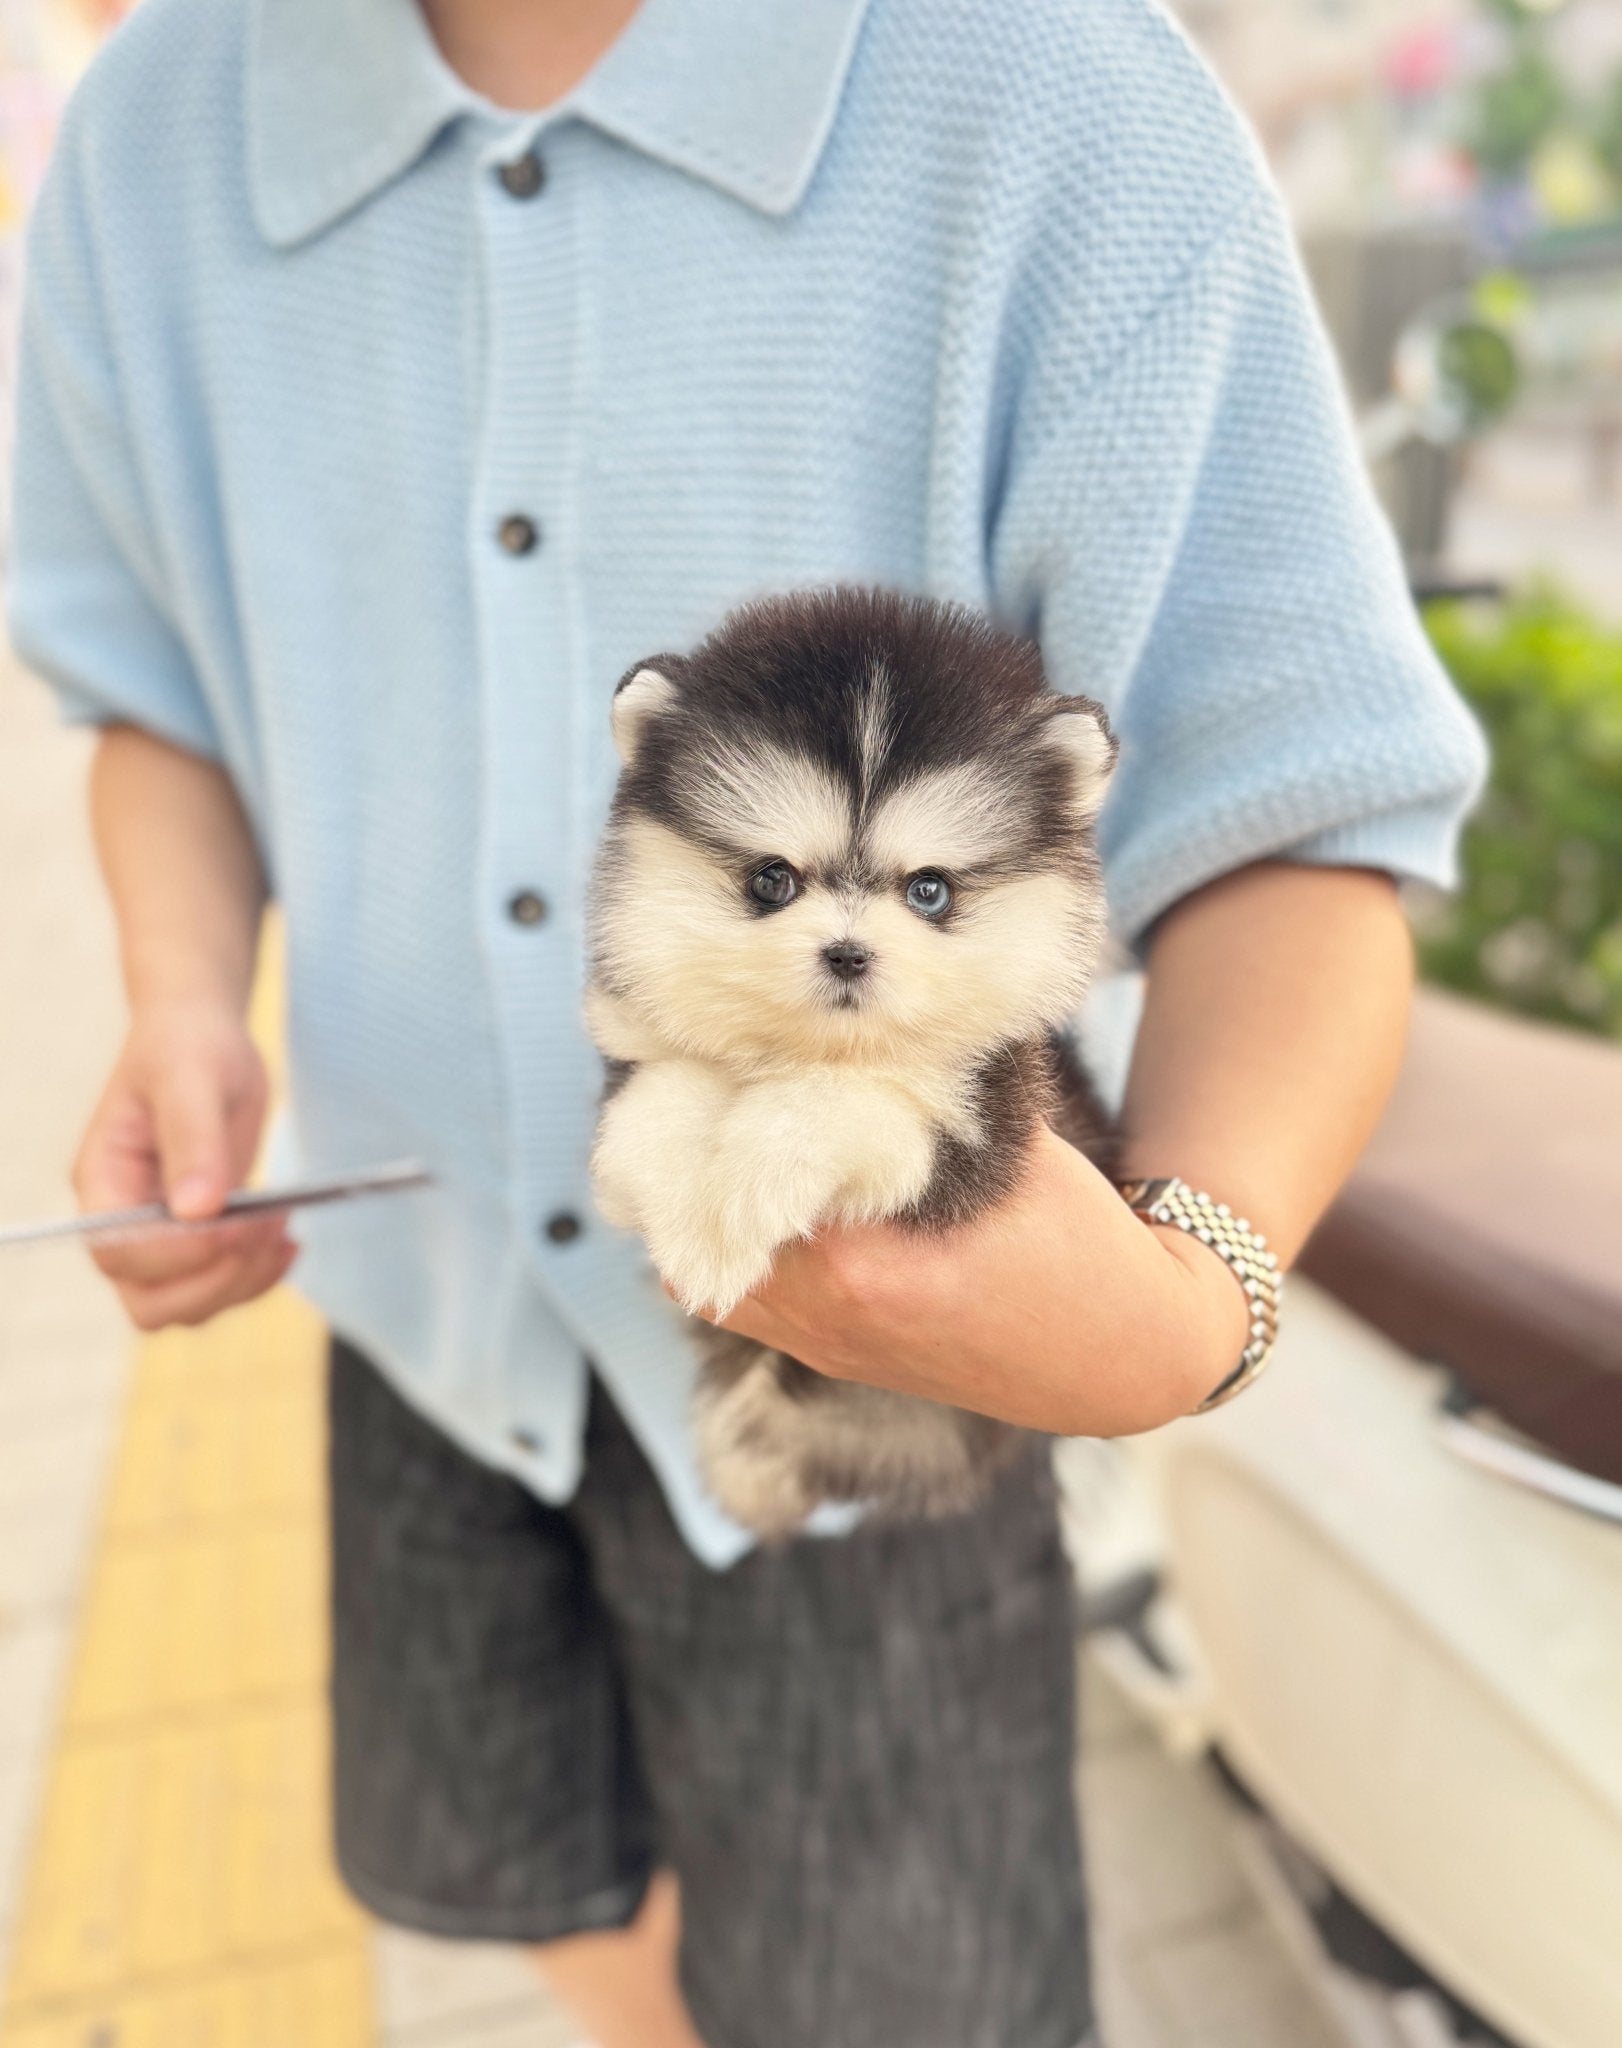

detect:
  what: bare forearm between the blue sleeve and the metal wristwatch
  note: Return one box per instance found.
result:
[1124,862,1413,1264]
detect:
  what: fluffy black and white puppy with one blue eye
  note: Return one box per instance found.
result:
[588,588,1116,1536]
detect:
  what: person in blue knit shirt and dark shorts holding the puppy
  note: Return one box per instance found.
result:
[12,0,1481,2048]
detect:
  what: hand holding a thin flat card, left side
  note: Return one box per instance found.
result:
[74,1004,297,1329]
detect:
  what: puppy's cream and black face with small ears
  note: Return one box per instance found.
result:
[596,606,1114,1065]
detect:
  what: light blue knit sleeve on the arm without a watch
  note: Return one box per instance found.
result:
[8,135,221,758]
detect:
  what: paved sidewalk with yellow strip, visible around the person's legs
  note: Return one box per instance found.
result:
[0,647,1333,2048]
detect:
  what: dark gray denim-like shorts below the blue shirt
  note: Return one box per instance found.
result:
[332,1343,1092,2048]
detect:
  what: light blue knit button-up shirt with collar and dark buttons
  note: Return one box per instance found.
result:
[12,0,1481,1565]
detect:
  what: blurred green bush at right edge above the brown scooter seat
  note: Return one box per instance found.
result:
[1415,588,1622,1038]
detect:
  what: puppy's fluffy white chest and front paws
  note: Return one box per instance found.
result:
[592,1018,969,1315]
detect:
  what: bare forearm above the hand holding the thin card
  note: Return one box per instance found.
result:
[90,725,264,1012]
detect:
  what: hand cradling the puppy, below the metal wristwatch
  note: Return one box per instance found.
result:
[704,1130,1249,1436]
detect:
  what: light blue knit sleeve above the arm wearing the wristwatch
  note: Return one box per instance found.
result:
[993,178,1485,942]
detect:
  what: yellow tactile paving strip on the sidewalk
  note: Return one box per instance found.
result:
[0,933,375,2048]
